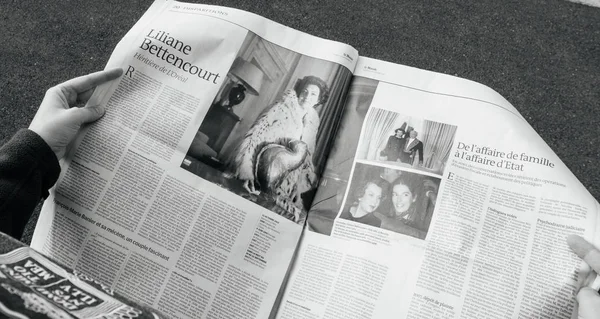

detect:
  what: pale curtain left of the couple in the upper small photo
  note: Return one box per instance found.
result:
[361,108,399,161]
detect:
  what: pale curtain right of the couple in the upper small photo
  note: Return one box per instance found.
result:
[422,121,456,172]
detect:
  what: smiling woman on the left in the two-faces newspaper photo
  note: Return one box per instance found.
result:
[340,178,387,227]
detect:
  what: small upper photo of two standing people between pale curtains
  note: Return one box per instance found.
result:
[356,108,456,175]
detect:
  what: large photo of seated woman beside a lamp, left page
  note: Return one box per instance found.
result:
[181,32,352,224]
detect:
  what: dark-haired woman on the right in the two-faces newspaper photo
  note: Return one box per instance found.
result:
[375,174,427,239]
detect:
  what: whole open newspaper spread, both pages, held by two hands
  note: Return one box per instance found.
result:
[23,1,600,318]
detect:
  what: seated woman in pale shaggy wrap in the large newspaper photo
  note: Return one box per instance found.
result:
[230,76,329,194]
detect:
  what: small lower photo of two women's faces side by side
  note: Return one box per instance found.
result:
[339,162,441,239]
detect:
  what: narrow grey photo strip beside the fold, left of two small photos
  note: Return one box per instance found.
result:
[307,76,379,236]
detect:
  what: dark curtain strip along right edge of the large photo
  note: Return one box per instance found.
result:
[313,67,352,174]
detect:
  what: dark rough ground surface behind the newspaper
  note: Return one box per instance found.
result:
[0,0,600,242]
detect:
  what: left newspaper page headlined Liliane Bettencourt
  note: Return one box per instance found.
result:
[32,1,357,318]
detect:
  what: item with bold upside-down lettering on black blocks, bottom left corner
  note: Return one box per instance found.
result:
[0,247,164,319]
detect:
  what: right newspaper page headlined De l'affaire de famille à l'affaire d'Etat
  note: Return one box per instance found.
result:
[277,57,599,319]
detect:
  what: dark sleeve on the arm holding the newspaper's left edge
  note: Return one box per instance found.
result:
[0,130,60,238]
